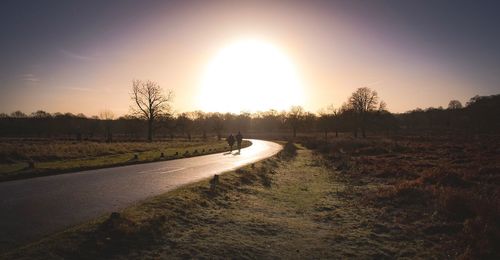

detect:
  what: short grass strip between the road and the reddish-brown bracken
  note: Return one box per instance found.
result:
[4,145,456,259]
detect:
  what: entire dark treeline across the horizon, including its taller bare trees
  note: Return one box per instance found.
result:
[0,80,500,142]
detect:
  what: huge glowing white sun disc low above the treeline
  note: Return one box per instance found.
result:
[198,39,303,113]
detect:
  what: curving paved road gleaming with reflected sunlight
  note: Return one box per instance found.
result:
[0,140,281,251]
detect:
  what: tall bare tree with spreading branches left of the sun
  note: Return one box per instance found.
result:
[131,80,173,142]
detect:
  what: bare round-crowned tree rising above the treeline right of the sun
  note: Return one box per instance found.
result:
[349,87,379,137]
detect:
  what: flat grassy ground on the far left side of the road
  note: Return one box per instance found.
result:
[0,140,251,181]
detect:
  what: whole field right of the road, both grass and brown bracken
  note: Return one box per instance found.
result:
[4,138,500,259]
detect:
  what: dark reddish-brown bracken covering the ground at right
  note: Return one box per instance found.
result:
[304,136,500,259]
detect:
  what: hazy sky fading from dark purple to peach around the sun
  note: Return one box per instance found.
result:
[0,0,500,116]
